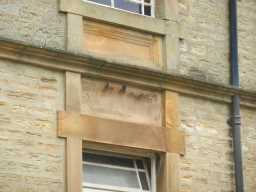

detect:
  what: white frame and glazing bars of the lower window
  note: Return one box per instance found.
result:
[82,150,156,192]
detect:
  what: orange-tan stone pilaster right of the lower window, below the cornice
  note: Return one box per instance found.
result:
[158,91,185,192]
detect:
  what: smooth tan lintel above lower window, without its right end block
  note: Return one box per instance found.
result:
[58,112,166,152]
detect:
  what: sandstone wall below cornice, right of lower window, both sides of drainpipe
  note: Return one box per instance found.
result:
[180,96,256,192]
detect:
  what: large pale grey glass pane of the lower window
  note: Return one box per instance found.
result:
[83,165,139,188]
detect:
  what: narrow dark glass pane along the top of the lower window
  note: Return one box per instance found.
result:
[83,153,134,168]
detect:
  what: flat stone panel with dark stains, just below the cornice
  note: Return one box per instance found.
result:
[82,78,162,126]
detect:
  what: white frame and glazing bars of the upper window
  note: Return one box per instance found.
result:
[82,0,155,17]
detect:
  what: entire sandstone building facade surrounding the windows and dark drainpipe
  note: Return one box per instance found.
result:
[0,0,256,192]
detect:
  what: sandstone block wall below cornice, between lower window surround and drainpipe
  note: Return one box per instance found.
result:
[180,96,234,192]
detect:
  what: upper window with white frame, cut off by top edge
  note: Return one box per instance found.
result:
[83,0,154,16]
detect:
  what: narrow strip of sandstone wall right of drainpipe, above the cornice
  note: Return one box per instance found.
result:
[238,0,256,91]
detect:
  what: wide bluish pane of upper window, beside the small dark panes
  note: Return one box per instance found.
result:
[114,0,142,14]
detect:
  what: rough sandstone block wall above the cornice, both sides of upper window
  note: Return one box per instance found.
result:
[0,0,256,90]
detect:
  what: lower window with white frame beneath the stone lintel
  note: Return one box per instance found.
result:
[83,152,156,192]
